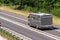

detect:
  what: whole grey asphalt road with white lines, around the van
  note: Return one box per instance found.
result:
[0,10,60,40]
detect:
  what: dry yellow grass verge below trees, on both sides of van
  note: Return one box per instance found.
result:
[0,6,60,26]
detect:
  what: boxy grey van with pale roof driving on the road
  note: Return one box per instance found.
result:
[28,13,53,29]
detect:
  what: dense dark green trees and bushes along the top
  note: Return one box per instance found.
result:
[0,0,60,16]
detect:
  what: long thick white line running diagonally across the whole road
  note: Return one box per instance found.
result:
[0,16,60,40]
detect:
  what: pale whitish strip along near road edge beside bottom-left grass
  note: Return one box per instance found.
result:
[1,27,32,40]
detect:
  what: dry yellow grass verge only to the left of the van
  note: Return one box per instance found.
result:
[0,6,29,16]
